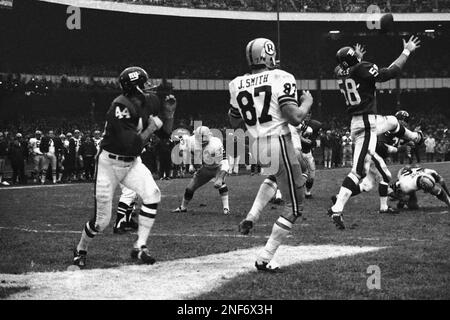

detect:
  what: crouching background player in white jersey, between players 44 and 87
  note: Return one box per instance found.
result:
[172,126,230,215]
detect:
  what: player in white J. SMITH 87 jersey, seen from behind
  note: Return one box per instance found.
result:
[229,38,313,272]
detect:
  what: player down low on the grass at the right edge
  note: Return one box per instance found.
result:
[389,166,450,209]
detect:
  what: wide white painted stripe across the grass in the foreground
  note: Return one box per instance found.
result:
[0,245,385,300]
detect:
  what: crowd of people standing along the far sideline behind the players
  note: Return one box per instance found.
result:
[0,104,450,184]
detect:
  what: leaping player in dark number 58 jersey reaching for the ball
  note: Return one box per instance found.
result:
[328,36,423,230]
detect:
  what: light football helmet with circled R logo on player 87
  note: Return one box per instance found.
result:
[245,38,278,69]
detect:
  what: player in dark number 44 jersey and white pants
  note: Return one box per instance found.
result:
[71,67,176,268]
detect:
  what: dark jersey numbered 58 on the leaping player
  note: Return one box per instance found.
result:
[336,61,399,115]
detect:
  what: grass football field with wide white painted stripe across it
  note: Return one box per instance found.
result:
[0,163,450,299]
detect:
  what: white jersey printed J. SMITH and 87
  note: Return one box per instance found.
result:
[229,69,298,138]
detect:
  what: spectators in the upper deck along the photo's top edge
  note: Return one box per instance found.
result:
[106,0,450,12]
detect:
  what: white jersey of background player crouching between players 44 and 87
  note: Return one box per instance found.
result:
[186,135,229,171]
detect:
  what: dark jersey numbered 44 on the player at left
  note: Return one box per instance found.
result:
[101,94,160,156]
